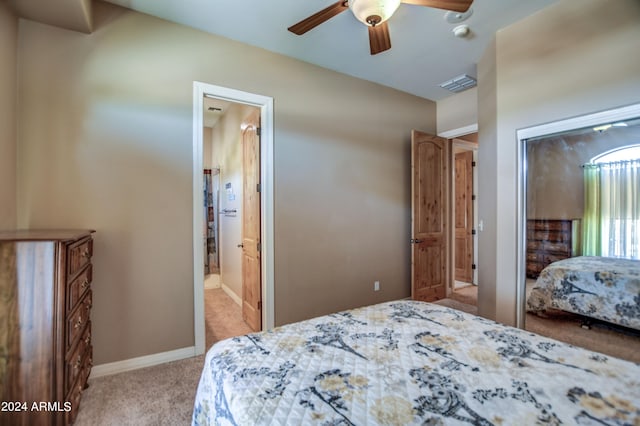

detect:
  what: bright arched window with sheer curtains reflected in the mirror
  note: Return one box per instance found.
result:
[583,144,640,259]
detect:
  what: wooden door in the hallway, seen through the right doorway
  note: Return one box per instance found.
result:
[454,151,473,283]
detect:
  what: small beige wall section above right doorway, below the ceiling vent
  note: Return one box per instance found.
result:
[438,87,478,133]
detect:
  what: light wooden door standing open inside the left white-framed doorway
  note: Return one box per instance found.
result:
[242,109,262,331]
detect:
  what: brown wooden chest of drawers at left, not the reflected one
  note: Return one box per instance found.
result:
[0,230,93,425]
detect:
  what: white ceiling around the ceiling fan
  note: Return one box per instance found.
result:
[102,0,557,101]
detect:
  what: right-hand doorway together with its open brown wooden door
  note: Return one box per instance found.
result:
[410,128,478,314]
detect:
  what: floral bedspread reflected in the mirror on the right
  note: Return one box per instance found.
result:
[527,256,640,330]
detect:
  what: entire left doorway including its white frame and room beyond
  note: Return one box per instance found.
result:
[193,82,274,354]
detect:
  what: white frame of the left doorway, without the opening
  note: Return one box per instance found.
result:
[192,81,275,355]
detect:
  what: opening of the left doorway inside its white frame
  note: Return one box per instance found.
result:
[203,99,261,349]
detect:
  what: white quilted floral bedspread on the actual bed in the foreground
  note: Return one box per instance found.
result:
[193,300,640,425]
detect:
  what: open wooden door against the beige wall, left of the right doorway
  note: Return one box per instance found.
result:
[411,130,451,302]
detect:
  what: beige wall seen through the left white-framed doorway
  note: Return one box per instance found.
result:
[212,104,257,299]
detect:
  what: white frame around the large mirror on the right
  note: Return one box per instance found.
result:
[516,103,640,329]
